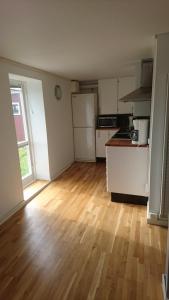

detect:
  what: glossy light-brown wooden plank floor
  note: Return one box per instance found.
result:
[0,163,166,300]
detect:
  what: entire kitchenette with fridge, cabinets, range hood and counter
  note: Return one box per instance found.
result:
[72,59,153,205]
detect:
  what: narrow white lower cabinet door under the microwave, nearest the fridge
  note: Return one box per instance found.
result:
[96,130,109,157]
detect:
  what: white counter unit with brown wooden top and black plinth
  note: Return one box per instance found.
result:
[105,138,149,204]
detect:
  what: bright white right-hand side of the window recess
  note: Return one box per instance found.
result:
[25,79,50,180]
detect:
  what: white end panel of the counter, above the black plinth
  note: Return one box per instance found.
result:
[106,146,148,196]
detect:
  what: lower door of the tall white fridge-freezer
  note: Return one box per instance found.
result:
[74,128,96,161]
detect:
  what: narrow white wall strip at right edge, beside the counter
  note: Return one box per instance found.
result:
[149,33,169,215]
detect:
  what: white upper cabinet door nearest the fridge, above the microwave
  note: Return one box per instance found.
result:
[99,79,118,114]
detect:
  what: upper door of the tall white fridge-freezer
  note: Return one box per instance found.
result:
[72,94,96,127]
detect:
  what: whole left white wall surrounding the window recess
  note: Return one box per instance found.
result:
[0,59,74,220]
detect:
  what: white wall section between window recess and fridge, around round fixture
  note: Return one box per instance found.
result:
[43,77,74,179]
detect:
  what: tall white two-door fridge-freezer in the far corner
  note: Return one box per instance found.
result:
[72,94,97,161]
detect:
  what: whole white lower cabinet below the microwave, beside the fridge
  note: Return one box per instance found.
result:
[96,129,118,157]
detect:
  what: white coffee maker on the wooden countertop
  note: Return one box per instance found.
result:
[132,119,149,145]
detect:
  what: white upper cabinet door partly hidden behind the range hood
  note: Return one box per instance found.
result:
[118,76,136,114]
